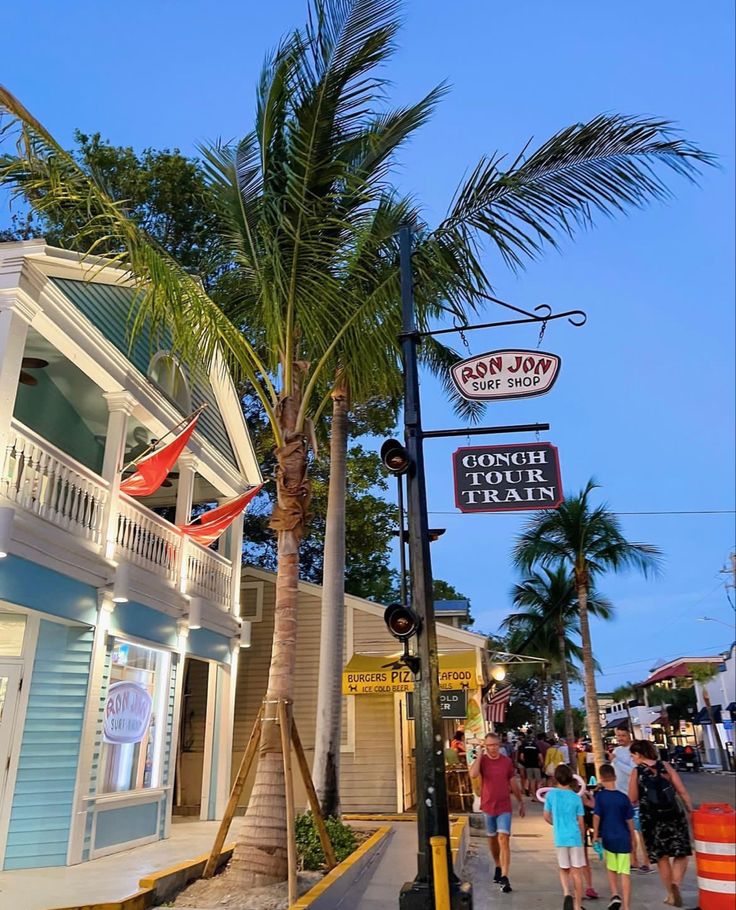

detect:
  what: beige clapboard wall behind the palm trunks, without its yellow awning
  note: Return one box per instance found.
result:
[232,568,480,812]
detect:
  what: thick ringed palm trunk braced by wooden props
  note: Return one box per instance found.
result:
[231,392,310,887]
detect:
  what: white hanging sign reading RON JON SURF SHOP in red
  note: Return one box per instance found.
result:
[452,351,561,401]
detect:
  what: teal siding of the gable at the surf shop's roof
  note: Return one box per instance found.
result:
[51,278,237,467]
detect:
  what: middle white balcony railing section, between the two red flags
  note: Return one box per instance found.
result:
[115,493,181,584]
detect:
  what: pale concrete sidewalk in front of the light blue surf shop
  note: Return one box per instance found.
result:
[0,818,219,910]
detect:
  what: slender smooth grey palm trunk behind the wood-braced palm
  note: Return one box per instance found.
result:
[312,378,349,816]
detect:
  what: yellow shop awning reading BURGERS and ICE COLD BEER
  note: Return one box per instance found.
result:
[342,651,483,695]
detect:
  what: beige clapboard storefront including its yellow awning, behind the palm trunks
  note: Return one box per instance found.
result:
[232,568,486,812]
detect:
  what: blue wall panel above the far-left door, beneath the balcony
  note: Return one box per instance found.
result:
[0,556,97,625]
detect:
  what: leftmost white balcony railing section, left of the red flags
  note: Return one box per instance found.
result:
[0,420,108,544]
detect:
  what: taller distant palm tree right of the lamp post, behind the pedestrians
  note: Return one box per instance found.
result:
[514,480,660,769]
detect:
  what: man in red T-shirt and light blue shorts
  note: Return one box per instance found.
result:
[469,733,526,894]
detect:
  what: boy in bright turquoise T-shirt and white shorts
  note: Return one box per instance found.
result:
[544,765,586,910]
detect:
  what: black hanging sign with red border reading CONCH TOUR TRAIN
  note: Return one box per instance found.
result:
[452,442,563,512]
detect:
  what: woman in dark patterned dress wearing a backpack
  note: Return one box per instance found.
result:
[629,740,693,907]
